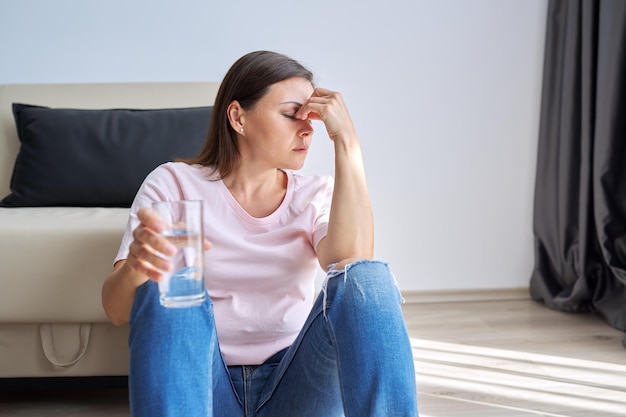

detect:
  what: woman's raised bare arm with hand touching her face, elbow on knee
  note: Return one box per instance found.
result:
[297,88,374,269]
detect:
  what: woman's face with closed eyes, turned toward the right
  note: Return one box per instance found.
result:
[239,78,313,170]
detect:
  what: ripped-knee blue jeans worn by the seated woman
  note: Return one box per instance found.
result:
[129,261,418,417]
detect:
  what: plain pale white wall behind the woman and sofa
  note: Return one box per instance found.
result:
[0,0,547,290]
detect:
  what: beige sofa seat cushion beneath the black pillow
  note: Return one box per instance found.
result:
[0,207,129,324]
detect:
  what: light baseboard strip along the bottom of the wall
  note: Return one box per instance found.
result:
[402,288,530,303]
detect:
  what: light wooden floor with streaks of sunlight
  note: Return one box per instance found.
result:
[0,297,626,417]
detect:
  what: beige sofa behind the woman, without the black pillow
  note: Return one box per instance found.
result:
[0,83,218,378]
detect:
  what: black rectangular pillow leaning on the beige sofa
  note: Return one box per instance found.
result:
[0,103,212,207]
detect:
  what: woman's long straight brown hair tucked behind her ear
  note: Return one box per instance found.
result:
[185,51,313,179]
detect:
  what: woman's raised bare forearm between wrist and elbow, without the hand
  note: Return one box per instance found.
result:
[322,136,374,265]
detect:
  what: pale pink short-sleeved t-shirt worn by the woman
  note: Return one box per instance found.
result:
[115,162,333,365]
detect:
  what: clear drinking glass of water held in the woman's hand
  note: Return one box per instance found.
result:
[152,200,206,308]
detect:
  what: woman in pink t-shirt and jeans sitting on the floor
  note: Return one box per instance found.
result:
[102,51,417,417]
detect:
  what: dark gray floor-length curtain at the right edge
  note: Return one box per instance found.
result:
[530,0,626,342]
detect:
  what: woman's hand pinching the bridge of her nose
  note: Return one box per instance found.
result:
[295,87,356,141]
